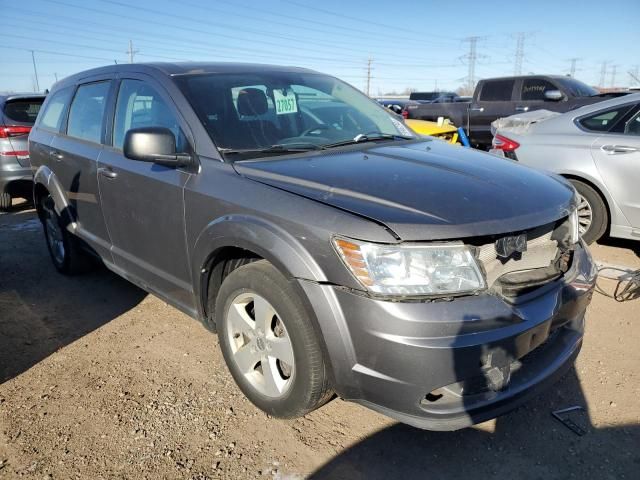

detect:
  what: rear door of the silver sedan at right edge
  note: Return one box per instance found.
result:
[583,105,640,229]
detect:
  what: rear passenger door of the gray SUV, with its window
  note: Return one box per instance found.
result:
[48,77,113,261]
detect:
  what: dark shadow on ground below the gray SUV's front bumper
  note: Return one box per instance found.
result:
[308,370,640,480]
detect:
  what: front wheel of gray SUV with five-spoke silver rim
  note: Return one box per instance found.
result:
[215,260,333,418]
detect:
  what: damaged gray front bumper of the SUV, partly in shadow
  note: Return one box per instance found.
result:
[301,245,596,430]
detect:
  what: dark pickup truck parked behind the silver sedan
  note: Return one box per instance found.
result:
[407,75,625,150]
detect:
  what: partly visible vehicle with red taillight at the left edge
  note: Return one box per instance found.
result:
[0,94,44,210]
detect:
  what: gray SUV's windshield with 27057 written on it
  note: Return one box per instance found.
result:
[176,71,414,158]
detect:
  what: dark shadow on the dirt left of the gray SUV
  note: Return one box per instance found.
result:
[0,205,147,383]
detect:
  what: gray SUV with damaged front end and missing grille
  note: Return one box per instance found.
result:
[30,63,596,430]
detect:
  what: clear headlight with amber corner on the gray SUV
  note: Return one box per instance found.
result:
[333,238,485,296]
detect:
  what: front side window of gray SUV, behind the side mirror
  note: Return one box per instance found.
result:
[113,79,188,152]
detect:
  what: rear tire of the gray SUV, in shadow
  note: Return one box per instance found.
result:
[41,195,93,275]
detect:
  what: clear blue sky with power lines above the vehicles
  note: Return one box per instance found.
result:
[0,0,640,95]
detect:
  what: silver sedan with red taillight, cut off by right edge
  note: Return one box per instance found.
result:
[492,93,640,243]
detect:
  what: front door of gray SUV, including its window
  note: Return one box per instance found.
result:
[98,76,194,310]
